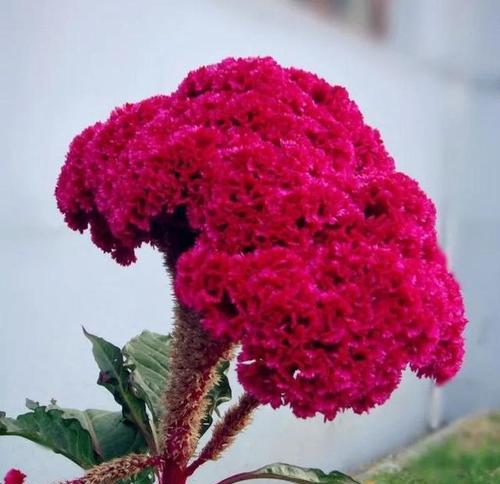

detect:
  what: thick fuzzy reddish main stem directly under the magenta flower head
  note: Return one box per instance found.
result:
[156,224,231,484]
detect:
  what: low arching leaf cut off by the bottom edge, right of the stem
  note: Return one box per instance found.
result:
[219,463,360,484]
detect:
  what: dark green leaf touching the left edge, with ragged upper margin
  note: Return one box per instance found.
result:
[0,401,99,469]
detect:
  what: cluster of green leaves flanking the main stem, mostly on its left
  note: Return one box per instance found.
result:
[0,329,231,484]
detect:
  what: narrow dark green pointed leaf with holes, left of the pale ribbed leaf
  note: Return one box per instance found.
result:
[83,328,156,451]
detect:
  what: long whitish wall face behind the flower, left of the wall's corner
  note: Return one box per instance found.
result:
[0,0,476,484]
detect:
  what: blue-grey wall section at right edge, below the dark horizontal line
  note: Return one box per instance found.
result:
[445,66,500,418]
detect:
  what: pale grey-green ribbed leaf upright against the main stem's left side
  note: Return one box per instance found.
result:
[123,331,171,423]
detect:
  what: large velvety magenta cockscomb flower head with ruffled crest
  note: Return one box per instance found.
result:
[56,58,465,419]
